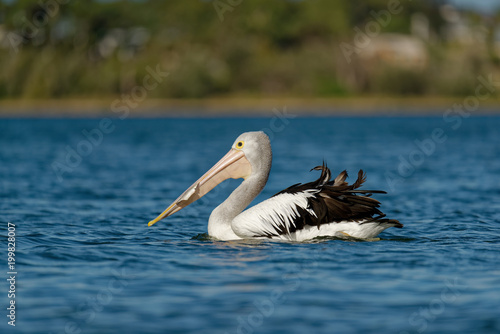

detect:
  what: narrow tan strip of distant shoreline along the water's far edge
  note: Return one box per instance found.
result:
[0,96,500,118]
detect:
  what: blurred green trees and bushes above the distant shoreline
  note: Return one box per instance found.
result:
[0,0,500,109]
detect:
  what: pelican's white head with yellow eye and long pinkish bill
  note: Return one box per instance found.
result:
[148,131,271,226]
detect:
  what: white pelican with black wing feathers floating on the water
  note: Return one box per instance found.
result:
[148,131,403,241]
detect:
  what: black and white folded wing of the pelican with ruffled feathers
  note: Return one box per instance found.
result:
[232,164,403,238]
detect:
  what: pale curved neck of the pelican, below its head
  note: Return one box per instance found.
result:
[208,169,269,240]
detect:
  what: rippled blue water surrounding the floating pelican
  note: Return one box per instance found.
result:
[0,117,500,333]
